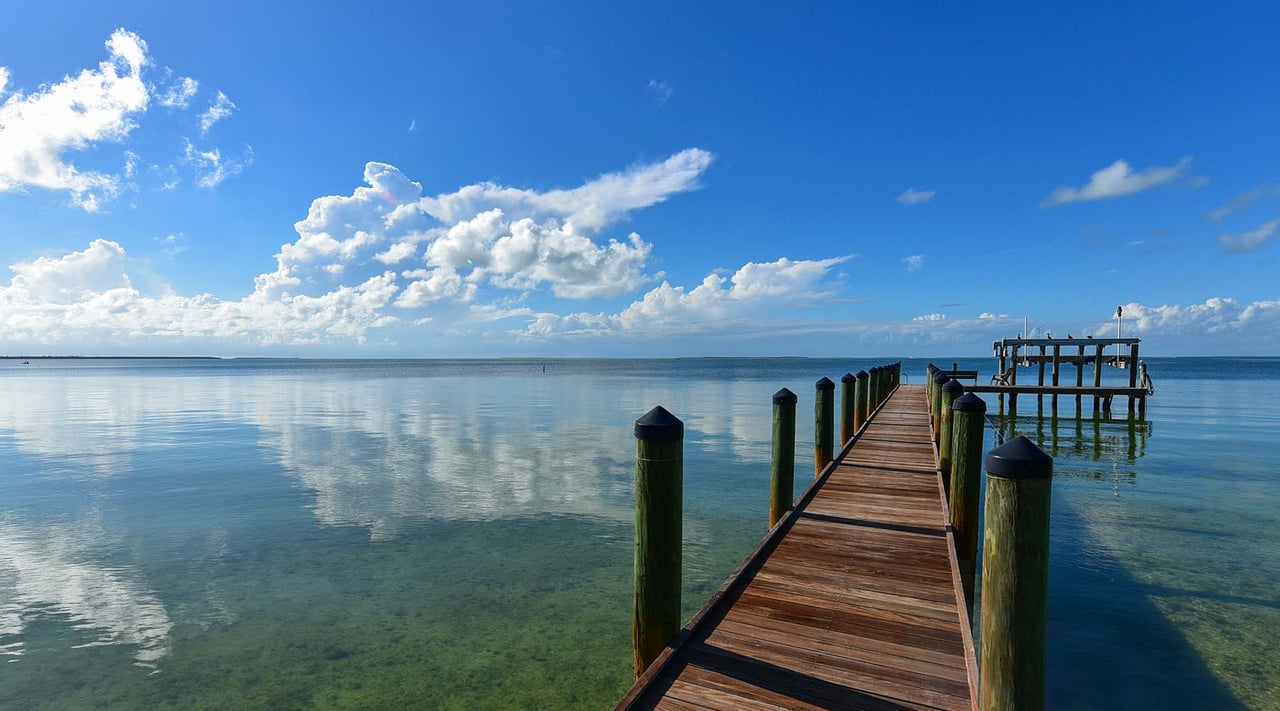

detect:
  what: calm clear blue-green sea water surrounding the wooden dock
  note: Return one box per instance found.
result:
[0,359,1280,708]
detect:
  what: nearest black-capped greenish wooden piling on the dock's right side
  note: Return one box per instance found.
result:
[979,436,1053,711]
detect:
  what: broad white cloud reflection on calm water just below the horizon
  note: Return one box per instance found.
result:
[0,374,829,539]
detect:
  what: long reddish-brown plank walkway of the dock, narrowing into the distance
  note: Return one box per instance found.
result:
[618,386,978,710]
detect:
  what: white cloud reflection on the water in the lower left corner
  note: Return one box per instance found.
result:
[0,520,173,667]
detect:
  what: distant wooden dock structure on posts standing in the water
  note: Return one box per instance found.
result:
[962,337,1156,419]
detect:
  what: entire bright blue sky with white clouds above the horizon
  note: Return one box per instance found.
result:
[0,3,1280,357]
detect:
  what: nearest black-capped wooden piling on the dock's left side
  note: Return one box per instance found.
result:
[631,405,685,678]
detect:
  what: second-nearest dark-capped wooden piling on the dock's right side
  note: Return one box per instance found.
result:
[943,392,987,614]
